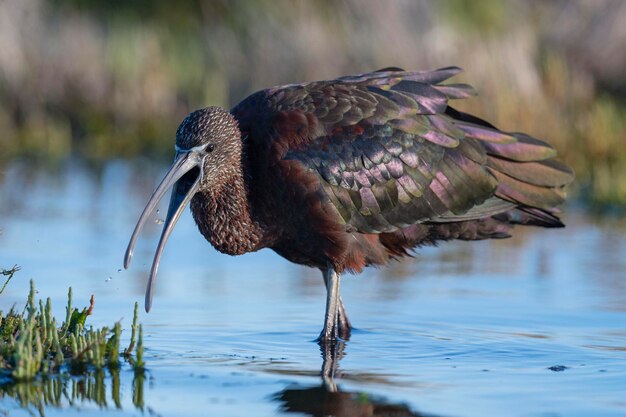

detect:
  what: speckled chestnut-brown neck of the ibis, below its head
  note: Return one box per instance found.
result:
[191,166,263,255]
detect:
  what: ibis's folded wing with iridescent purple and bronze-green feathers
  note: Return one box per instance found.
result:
[232,67,573,233]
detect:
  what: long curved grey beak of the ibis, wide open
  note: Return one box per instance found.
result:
[124,150,203,312]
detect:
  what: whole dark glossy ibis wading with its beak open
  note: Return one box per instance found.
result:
[124,67,574,343]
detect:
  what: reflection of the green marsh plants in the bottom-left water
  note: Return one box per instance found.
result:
[0,369,145,416]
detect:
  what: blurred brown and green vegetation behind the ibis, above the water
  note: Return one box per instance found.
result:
[0,0,626,206]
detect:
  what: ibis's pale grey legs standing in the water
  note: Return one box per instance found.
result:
[319,266,351,343]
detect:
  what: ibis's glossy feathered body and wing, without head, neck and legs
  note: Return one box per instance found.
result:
[231,67,573,270]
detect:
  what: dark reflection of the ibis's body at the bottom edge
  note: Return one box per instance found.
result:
[273,384,434,417]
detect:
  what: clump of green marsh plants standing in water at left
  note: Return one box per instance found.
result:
[0,278,144,385]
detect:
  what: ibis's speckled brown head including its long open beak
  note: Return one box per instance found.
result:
[124,107,242,311]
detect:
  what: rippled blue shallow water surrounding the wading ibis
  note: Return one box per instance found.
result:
[0,161,626,417]
